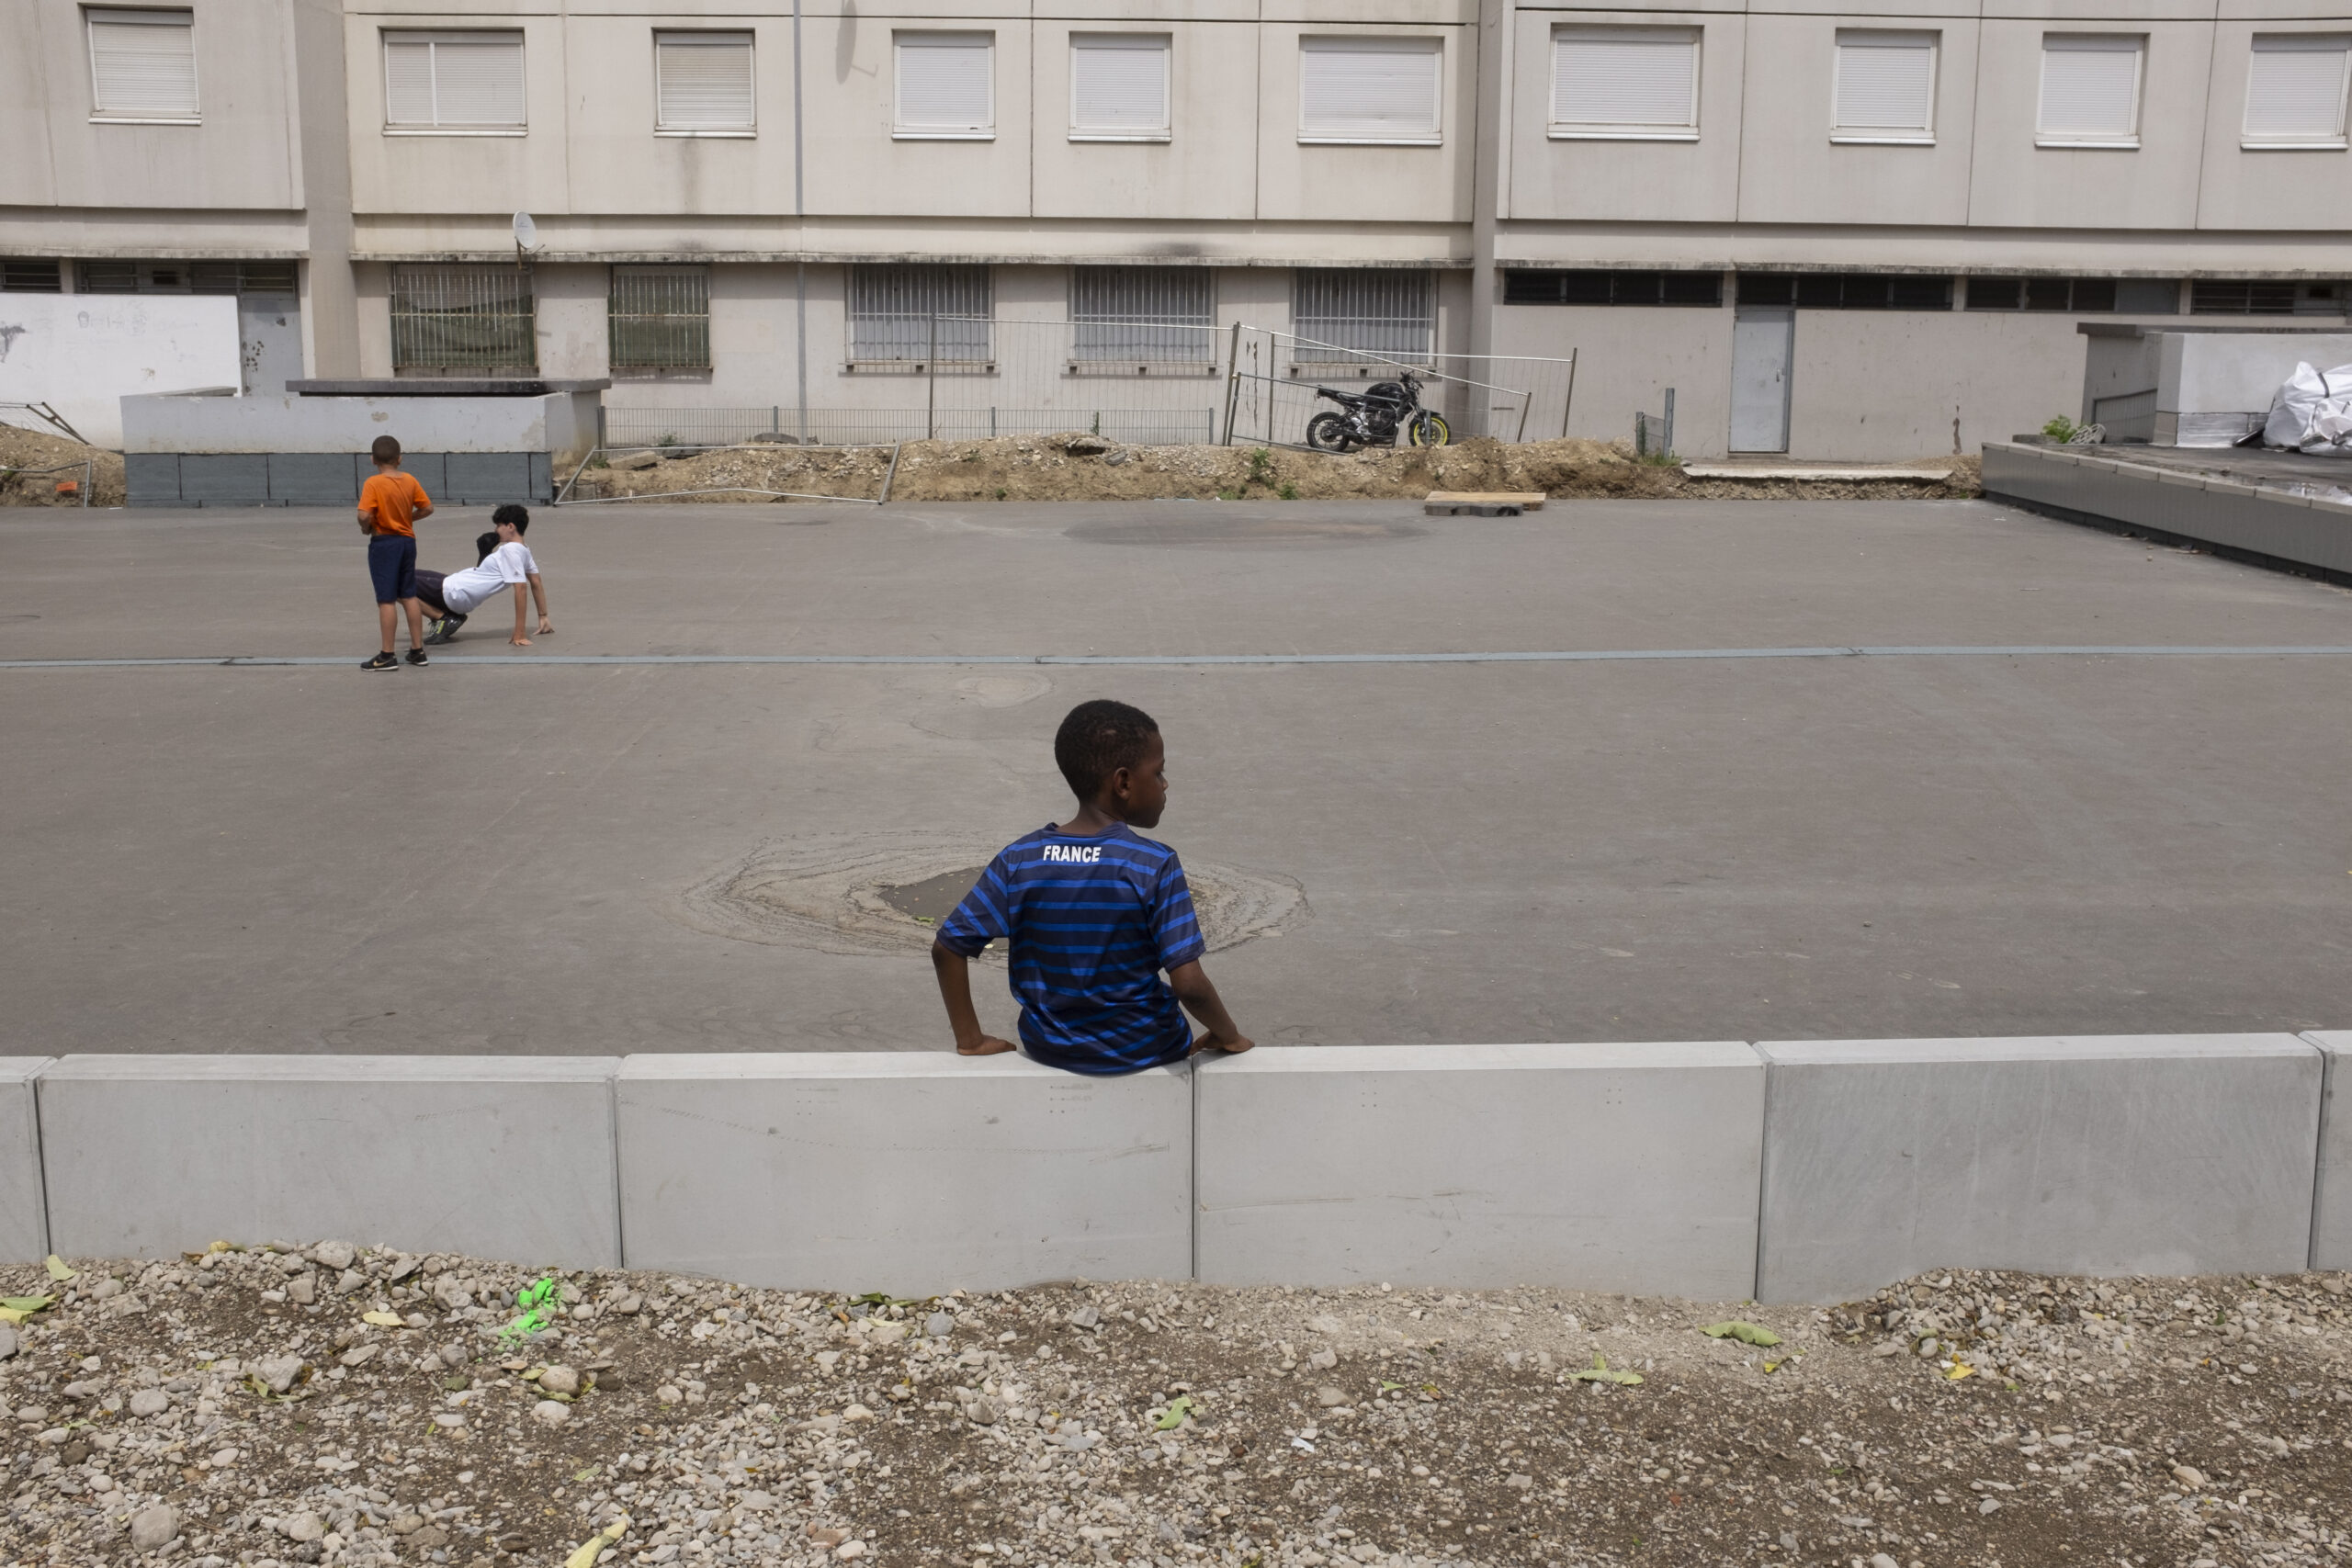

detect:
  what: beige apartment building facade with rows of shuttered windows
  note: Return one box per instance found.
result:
[0,0,2352,458]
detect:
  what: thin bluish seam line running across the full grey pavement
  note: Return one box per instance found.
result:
[0,644,2352,670]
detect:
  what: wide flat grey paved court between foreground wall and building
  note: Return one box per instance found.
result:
[0,499,2352,1055]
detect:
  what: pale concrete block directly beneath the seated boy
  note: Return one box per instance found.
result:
[616,1051,1193,1295]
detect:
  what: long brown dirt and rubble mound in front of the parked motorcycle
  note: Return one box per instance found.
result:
[571,433,1978,501]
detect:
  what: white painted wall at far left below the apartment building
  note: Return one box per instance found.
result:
[0,294,244,446]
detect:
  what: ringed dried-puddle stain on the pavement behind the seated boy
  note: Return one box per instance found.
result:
[663,835,1315,962]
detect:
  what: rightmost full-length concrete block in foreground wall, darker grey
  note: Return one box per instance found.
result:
[1757,1034,2322,1303]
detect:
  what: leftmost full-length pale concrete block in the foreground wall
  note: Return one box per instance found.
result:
[40,1055,621,1267]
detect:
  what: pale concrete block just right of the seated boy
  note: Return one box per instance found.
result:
[1197,1042,1764,1300]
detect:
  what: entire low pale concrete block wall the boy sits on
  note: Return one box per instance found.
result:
[0,1034,2352,1300]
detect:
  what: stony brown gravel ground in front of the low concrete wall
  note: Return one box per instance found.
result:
[0,1244,2352,1568]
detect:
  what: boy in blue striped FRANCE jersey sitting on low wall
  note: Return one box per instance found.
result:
[932,701,1253,1075]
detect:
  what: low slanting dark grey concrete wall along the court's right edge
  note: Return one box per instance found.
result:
[1985,442,2352,571]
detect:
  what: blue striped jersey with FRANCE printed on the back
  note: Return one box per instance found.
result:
[938,823,1206,1075]
